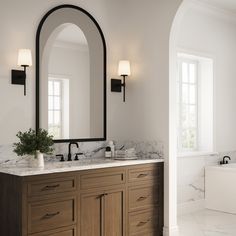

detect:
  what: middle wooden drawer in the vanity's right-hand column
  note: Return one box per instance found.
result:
[129,184,160,211]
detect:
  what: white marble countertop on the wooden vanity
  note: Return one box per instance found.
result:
[0,158,164,176]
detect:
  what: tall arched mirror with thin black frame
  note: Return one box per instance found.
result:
[36,5,106,142]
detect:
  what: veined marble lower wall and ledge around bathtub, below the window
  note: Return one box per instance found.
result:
[177,151,236,214]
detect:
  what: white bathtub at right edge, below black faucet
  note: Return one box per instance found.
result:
[205,163,236,214]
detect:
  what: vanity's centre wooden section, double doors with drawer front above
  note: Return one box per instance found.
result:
[80,168,126,236]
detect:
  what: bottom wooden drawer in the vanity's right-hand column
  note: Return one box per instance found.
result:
[129,209,159,236]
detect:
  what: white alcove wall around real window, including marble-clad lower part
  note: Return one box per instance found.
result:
[175,1,236,212]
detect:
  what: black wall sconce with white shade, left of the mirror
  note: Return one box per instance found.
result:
[11,49,32,96]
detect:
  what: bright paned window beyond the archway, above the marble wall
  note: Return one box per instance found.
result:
[178,58,198,151]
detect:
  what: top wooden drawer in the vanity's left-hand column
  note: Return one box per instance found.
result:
[28,176,76,197]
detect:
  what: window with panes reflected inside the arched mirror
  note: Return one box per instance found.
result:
[48,78,62,139]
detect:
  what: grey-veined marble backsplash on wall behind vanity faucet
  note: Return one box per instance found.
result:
[0,141,163,164]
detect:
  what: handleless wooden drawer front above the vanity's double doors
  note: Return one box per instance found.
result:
[80,170,125,190]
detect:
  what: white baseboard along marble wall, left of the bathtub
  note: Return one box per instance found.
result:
[177,199,205,215]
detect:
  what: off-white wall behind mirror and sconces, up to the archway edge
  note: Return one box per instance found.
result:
[0,0,182,235]
